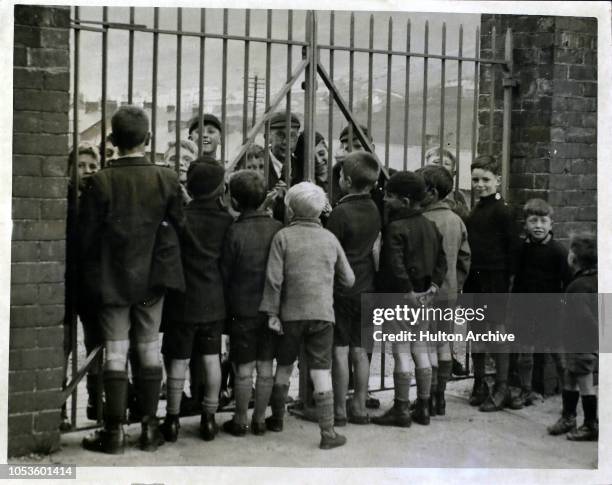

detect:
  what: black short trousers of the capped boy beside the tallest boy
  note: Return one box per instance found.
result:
[162,320,225,360]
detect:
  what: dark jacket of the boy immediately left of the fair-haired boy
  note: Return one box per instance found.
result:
[221,211,283,317]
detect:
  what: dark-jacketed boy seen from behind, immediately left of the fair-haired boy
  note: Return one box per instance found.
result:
[221,170,283,436]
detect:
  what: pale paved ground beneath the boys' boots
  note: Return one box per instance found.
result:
[20,381,597,469]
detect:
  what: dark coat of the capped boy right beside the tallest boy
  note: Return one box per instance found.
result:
[164,195,233,324]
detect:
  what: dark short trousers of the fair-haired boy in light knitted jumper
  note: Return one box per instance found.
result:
[276,320,334,370]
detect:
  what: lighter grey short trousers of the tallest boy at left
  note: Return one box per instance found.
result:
[98,295,164,343]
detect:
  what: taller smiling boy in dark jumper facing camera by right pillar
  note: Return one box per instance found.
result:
[463,156,521,411]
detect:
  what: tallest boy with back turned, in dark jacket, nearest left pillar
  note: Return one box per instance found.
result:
[79,106,184,453]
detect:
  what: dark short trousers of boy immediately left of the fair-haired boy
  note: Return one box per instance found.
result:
[229,315,279,365]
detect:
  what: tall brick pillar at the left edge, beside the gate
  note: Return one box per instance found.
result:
[8,5,70,456]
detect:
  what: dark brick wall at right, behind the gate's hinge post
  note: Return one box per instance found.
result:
[478,15,597,239]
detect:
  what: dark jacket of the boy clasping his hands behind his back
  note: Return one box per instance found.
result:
[379,205,447,293]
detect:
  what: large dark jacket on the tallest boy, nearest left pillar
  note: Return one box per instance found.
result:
[79,157,185,306]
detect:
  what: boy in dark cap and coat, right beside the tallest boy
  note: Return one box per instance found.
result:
[162,157,233,441]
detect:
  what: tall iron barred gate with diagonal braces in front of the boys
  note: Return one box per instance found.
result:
[64,7,513,429]
